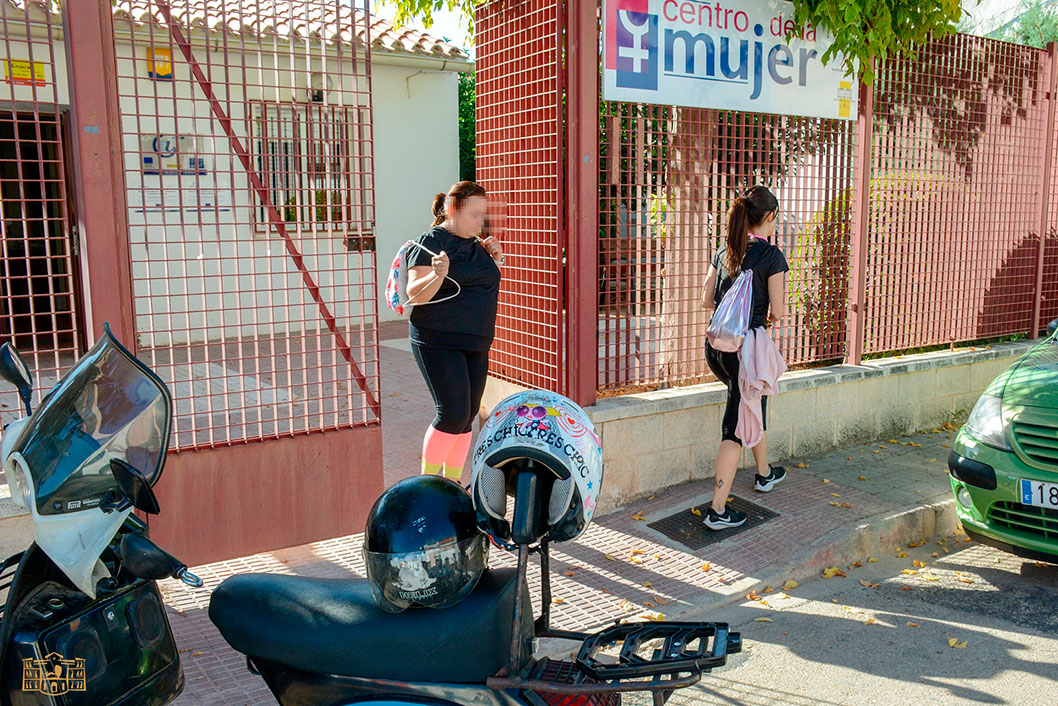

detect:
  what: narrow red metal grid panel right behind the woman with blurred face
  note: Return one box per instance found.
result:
[476,0,565,390]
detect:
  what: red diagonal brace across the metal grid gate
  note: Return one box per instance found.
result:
[154,0,382,419]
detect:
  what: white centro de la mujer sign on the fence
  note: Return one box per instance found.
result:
[603,0,858,120]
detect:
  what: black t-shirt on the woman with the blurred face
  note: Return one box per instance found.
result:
[407,227,500,350]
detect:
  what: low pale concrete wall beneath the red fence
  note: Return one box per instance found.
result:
[587,342,1033,512]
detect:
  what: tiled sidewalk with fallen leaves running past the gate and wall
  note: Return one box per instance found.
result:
[162,353,954,706]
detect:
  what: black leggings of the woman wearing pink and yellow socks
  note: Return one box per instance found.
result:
[412,343,489,434]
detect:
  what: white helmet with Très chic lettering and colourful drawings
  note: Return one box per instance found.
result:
[471,390,602,542]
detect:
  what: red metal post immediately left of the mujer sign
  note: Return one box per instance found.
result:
[560,0,599,405]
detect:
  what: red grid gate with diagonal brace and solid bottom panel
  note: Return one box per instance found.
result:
[103,0,382,561]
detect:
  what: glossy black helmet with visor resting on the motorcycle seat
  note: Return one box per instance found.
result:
[364,475,489,613]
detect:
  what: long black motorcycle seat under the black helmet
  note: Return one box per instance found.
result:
[209,569,533,684]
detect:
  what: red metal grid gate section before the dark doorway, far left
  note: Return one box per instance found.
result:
[0,0,84,414]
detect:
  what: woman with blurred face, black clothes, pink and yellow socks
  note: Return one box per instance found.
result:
[407,181,504,481]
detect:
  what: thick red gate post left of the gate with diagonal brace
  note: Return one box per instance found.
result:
[62,2,136,352]
